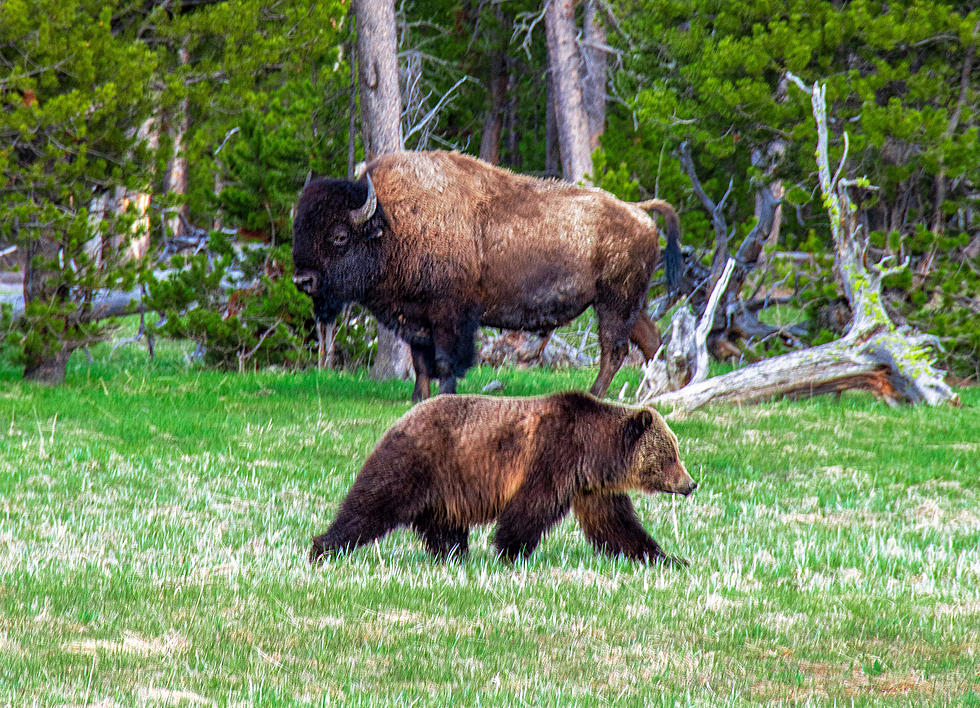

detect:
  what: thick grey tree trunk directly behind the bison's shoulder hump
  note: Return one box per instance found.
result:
[354,0,412,379]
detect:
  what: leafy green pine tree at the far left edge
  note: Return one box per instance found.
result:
[0,0,155,383]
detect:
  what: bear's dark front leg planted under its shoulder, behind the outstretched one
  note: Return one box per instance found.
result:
[493,482,571,561]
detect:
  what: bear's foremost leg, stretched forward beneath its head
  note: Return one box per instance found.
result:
[572,493,687,565]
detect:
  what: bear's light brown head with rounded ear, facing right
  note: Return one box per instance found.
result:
[623,408,698,496]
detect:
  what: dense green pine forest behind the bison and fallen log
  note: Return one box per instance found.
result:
[0,0,980,388]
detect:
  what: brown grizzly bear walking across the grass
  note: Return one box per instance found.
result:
[309,392,697,565]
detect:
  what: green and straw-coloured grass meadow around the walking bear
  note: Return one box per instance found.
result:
[0,336,980,706]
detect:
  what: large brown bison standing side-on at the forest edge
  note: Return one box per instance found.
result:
[293,151,680,402]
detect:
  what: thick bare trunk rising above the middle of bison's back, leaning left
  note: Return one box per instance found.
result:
[544,0,592,182]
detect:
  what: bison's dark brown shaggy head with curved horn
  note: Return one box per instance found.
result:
[293,177,387,322]
